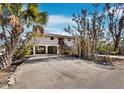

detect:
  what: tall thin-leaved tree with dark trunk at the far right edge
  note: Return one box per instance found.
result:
[104,3,124,51]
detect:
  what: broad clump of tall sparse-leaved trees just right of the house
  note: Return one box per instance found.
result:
[64,6,104,59]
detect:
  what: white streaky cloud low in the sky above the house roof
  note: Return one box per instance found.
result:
[44,15,74,34]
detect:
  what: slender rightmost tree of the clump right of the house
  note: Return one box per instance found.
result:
[89,4,105,60]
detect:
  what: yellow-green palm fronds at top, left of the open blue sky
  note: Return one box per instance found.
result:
[21,4,48,26]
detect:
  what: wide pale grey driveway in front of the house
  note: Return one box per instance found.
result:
[10,55,124,89]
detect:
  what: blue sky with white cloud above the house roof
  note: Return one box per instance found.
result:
[39,3,103,34]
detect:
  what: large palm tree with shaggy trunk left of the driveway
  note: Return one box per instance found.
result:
[0,3,47,68]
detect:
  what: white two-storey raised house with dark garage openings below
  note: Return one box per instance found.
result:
[32,33,73,55]
